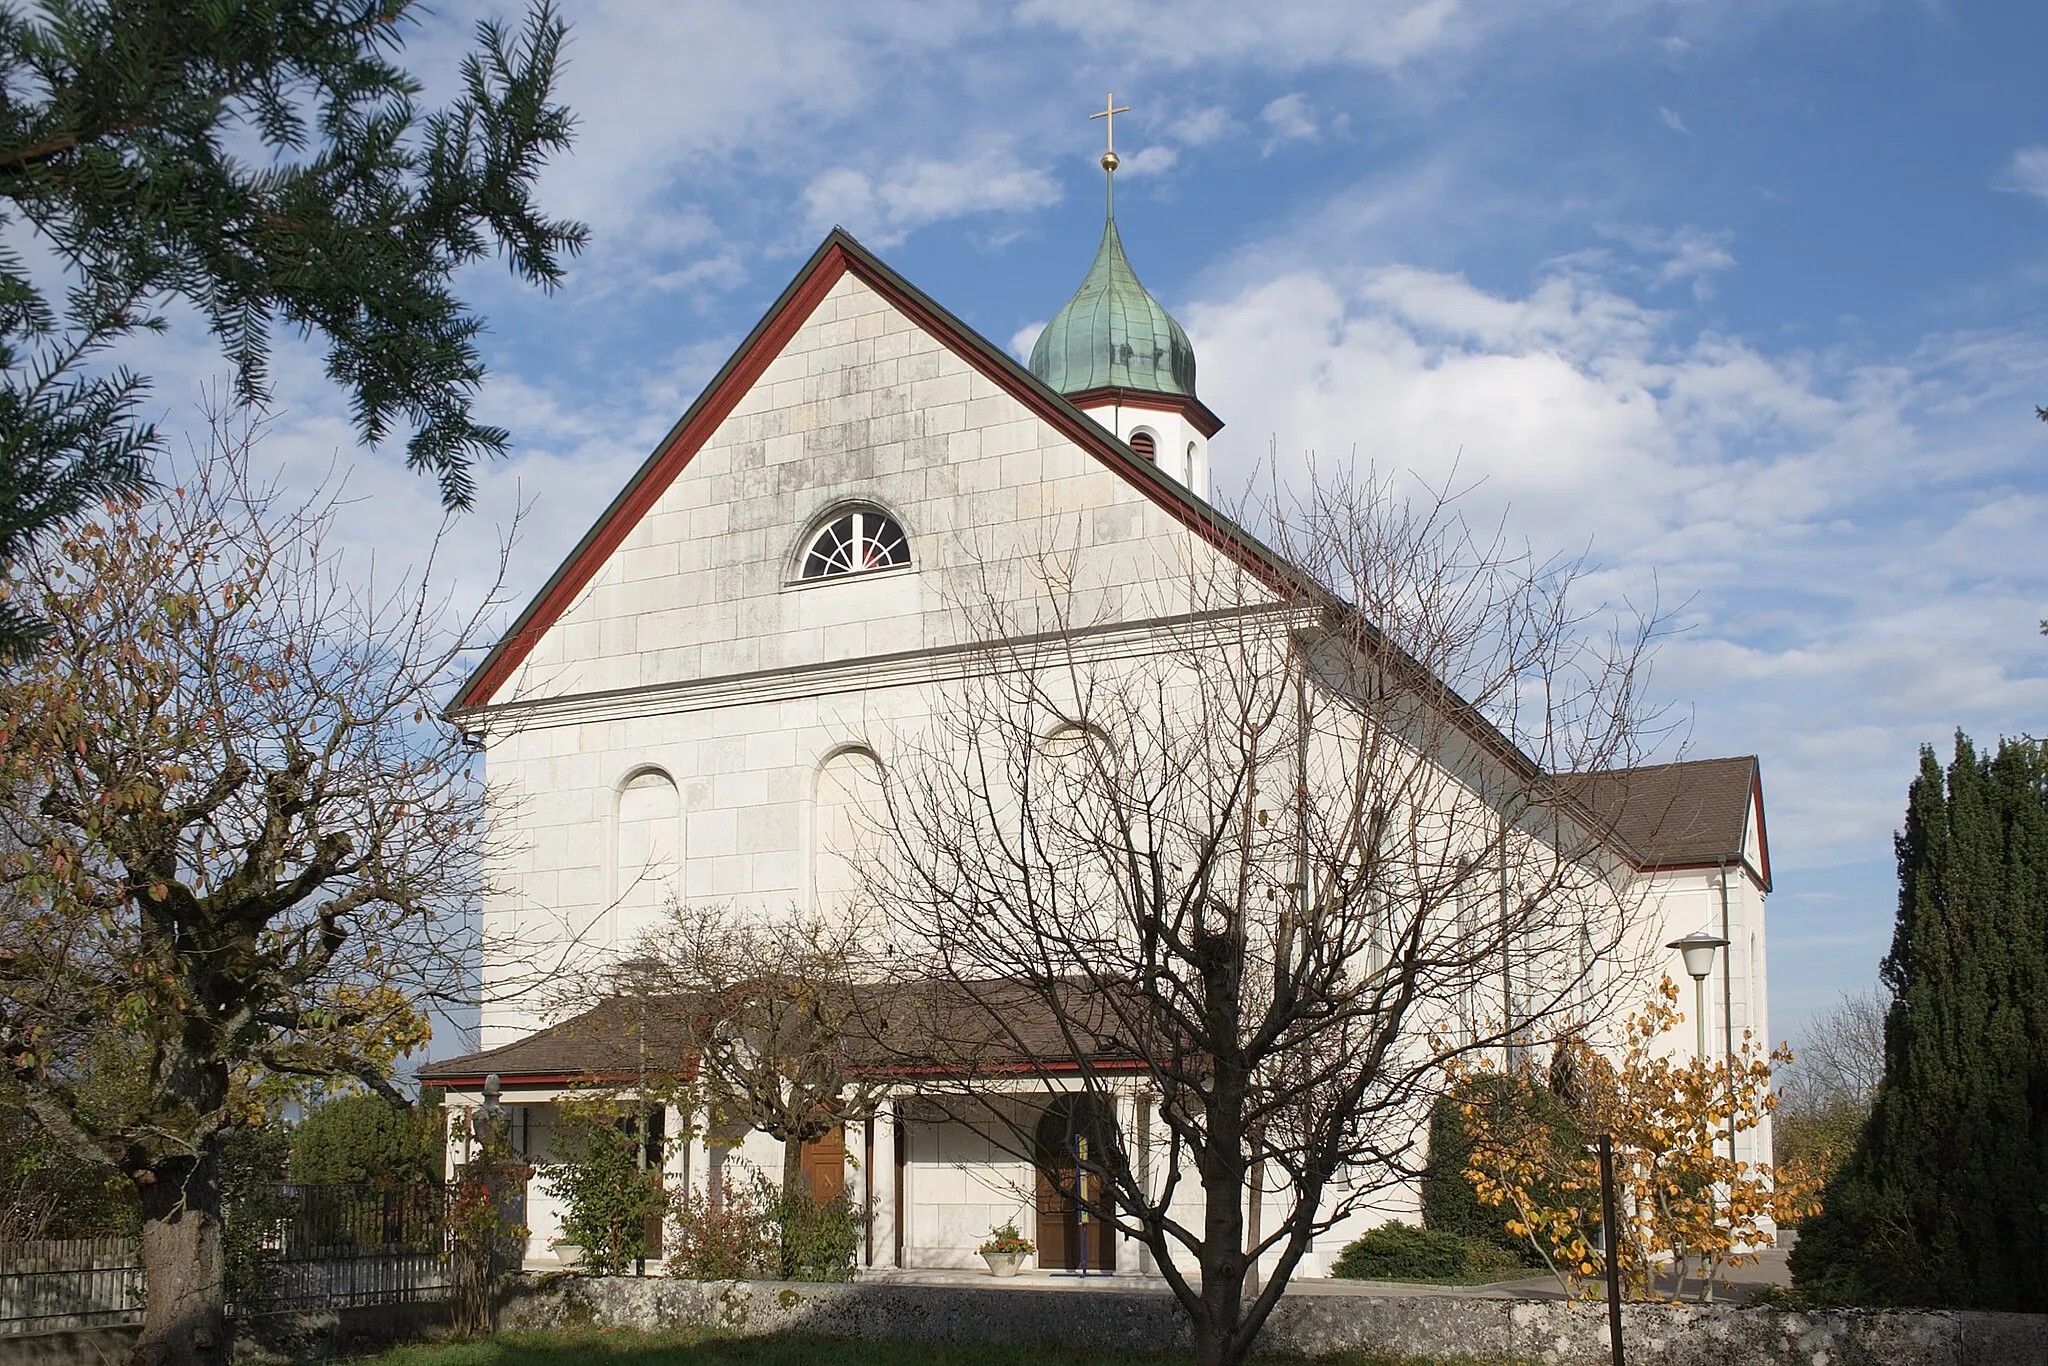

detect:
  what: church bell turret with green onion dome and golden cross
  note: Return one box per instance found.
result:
[1030,100,1223,498]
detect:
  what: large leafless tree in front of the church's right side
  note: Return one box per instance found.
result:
[874,477,1653,1366]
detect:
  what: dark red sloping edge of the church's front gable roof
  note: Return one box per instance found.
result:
[449,227,1307,713]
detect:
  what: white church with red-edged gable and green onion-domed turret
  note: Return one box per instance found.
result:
[422,149,1769,1276]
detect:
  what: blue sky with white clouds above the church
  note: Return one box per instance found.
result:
[156,0,2048,1038]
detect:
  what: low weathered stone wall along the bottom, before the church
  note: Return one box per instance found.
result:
[504,1276,2048,1366]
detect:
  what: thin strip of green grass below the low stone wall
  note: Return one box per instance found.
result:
[373,1329,1511,1366]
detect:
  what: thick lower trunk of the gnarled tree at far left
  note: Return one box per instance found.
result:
[135,1153,229,1366]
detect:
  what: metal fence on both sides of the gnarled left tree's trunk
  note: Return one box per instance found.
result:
[0,1184,451,1333]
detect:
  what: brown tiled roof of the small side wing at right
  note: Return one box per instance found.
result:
[1565,754,1769,887]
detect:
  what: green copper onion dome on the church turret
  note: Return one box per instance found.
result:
[1030,197,1194,397]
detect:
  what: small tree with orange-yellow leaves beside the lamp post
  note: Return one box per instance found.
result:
[1452,977,1812,1300]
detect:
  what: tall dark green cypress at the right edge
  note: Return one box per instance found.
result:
[1792,733,2048,1311]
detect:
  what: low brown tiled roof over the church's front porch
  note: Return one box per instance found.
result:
[420,981,1137,1085]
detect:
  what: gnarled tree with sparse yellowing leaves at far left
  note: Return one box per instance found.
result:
[0,413,516,1364]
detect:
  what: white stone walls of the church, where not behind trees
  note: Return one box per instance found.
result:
[453,232,1767,1276]
